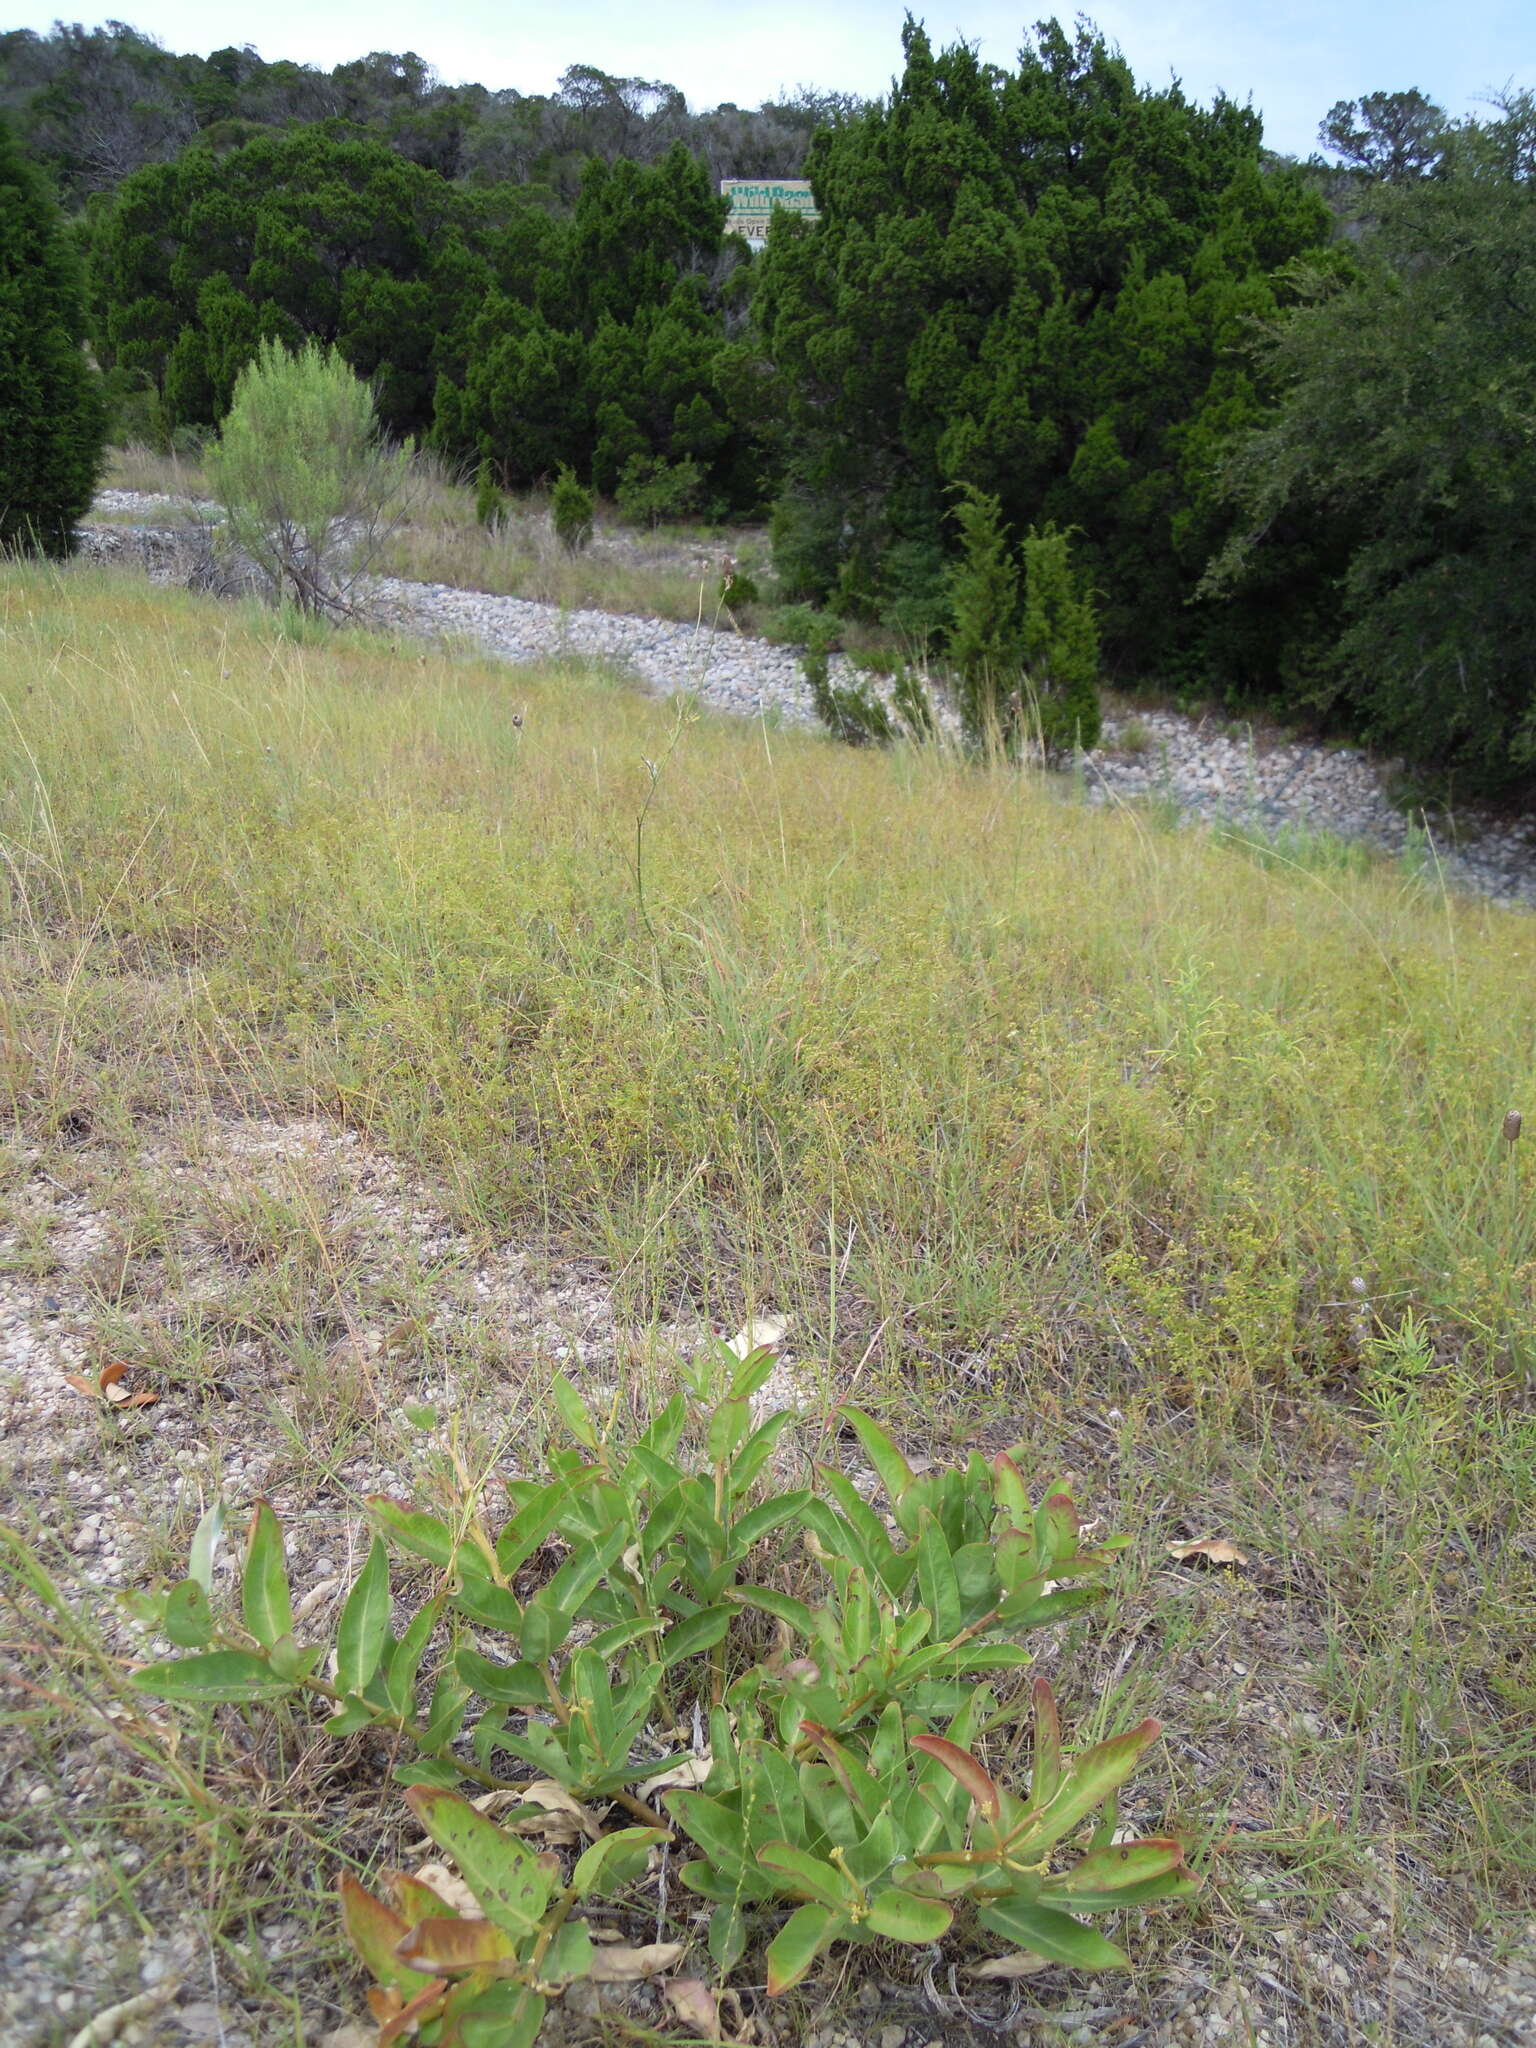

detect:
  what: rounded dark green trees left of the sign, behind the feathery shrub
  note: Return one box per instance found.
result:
[84,123,766,518]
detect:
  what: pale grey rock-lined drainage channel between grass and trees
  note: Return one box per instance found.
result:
[82,492,1536,907]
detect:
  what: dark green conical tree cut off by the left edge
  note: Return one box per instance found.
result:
[0,121,106,555]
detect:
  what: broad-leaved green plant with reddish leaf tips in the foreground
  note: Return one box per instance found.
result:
[133,1346,1194,2015]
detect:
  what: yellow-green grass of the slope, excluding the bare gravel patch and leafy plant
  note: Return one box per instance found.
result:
[0,569,1536,2040]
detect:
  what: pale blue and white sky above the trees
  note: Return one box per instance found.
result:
[14,0,1536,156]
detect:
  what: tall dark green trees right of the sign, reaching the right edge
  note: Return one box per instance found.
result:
[754,23,1536,791]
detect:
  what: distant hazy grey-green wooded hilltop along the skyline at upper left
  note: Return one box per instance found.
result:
[0,23,860,209]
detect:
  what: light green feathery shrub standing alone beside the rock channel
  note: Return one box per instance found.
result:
[207,342,410,616]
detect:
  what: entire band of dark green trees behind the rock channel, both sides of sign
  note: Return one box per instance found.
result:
[10,20,1536,791]
